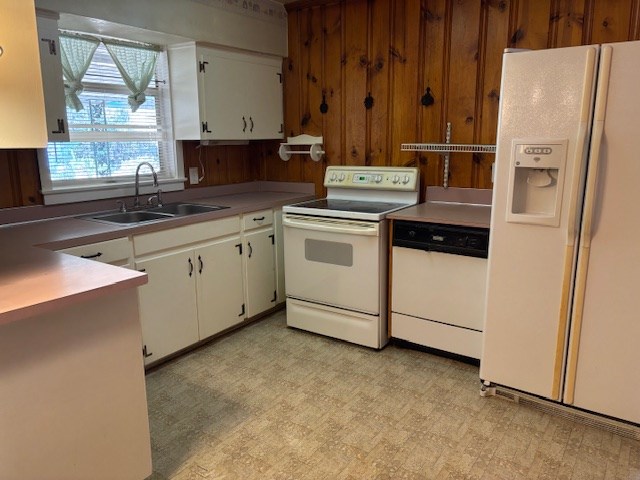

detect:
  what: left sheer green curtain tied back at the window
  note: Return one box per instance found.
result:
[60,35,100,112]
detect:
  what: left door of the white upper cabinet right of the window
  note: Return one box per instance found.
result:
[199,49,249,140]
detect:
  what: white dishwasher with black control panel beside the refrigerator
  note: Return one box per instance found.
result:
[391,220,489,359]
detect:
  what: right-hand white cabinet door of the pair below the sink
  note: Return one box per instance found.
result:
[195,236,246,339]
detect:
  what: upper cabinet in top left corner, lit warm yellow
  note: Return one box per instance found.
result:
[0,0,47,148]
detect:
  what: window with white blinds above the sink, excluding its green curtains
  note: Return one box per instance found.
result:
[40,36,184,204]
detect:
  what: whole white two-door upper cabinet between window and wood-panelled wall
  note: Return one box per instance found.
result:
[169,44,284,140]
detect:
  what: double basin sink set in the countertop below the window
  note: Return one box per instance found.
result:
[81,203,229,225]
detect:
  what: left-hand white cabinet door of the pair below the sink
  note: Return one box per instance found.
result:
[136,250,199,364]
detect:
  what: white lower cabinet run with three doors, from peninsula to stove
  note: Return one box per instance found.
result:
[133,209,277,365]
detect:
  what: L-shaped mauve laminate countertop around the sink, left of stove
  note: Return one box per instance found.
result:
[0,182,314,325]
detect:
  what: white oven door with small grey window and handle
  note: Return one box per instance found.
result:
[282,213,386,315]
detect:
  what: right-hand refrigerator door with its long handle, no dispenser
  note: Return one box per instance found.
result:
[564,42,640,423]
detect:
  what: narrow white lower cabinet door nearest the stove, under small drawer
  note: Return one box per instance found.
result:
[244,228,277,317]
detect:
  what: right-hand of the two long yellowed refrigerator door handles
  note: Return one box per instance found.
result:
[564,46,613,404]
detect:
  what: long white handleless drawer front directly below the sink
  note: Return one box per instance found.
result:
[133,216,240,257]
